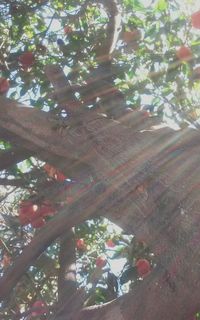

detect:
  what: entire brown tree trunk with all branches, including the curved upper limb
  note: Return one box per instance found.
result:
[3,0,200,320]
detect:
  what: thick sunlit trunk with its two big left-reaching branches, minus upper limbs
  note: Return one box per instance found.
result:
[0,62,200,320]
